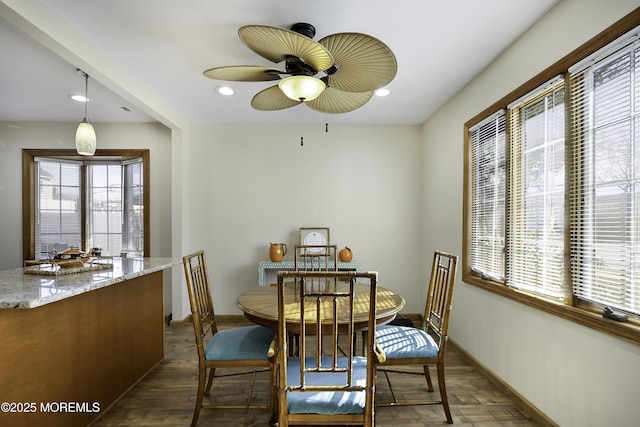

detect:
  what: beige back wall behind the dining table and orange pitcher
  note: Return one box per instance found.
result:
[184,124,424,318]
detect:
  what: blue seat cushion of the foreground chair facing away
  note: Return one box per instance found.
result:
[287,357,367,415]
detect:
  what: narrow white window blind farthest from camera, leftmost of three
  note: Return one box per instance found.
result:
[469,111,506,280]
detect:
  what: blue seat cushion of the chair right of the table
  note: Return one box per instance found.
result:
[376,325,438,359]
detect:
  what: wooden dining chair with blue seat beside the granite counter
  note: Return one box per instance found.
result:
[182,251,276,427]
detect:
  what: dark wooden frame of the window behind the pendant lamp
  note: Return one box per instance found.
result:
[22,149,151,261]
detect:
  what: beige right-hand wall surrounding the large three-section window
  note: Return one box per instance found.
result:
[423,0,640,427]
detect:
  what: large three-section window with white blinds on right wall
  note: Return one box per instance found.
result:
[463,20,640,322]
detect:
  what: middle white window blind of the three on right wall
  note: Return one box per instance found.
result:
[507,78,570,299]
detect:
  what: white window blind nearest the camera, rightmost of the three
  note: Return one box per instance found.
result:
[570,34,640,313]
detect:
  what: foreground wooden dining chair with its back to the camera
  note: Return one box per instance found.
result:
[272,271,383,427]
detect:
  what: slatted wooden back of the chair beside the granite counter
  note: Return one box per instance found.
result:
[183,251,218,360]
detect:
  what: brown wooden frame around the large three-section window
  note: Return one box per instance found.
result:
[461,8,640,344]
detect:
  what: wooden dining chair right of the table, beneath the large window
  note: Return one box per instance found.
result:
[376,251,458,424]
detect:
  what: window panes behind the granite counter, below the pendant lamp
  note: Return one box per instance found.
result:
[34,158,144,258]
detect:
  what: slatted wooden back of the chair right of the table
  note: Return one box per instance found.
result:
[423,251,458,354]
